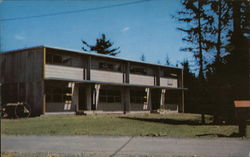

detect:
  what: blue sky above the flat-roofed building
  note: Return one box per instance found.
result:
[0,0,193,66]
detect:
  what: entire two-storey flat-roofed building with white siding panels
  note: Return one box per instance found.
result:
[0,46,185,116]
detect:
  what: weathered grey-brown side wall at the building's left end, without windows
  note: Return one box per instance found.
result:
[0,48,44,115]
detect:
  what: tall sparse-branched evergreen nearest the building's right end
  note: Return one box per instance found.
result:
[177,0,213,124]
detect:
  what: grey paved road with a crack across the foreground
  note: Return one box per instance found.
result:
[1,135,250,157]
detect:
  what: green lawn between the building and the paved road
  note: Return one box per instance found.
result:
[1,114,250,137]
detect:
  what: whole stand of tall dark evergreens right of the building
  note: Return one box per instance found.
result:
[173,0,250,120]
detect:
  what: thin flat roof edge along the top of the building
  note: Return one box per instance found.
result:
[0,45,183,70]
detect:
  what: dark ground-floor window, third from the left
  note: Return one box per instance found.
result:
[130,90,147,104]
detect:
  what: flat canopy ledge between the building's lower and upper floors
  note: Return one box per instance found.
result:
[44,77,187,90]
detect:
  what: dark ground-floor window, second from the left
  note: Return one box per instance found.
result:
[99,89,121,103]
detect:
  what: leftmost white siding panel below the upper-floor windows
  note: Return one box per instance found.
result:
[45,64,83,80]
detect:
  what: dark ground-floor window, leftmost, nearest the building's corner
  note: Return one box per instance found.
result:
[46,86,71,103]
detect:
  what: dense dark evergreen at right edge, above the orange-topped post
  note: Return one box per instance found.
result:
[225,0,250,100]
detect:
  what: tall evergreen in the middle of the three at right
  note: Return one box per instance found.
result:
[206,0,232,122]
